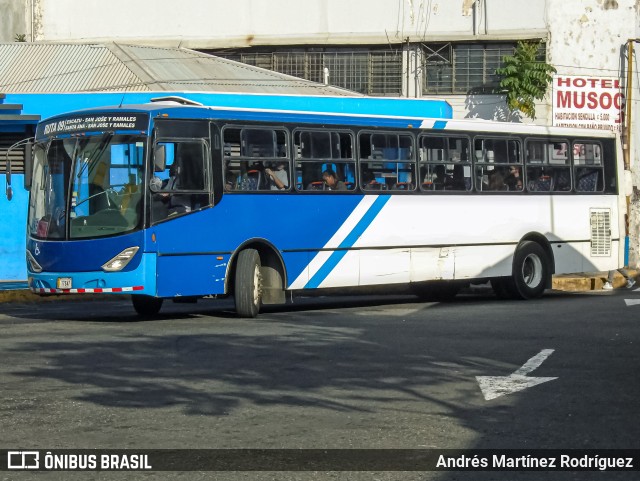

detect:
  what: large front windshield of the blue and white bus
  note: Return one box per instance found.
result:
[28,133,146,240]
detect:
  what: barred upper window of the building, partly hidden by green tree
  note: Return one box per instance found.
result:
[422,42,545,94]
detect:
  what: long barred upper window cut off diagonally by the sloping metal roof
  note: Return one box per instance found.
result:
[208,47,402,96]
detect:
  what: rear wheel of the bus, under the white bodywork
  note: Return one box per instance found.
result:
[508,241,550,299]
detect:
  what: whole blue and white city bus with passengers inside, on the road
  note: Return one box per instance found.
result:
[26,95,625,317]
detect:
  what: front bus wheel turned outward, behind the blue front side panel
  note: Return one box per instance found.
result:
[234,249,262,318]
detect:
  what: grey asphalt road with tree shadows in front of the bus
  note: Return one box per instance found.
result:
[0,290,640,481]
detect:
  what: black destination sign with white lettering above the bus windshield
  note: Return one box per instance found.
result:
[36,112,149,137]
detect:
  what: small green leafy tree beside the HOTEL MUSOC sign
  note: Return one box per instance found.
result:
[496,40,556,119]
